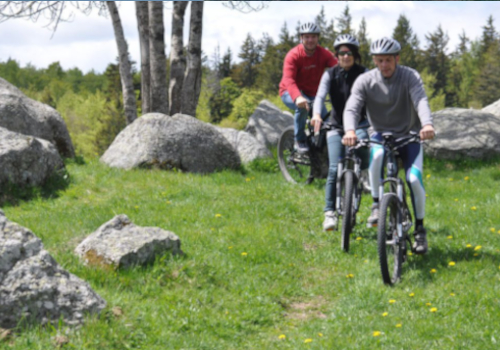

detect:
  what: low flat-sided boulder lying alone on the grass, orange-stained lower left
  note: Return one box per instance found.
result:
[75,214,182,269]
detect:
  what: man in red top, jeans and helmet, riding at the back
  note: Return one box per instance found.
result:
[280,23,337,153]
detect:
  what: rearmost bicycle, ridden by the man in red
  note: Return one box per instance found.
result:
[278,108,329,185]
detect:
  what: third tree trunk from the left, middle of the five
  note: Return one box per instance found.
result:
[148,1,168,114]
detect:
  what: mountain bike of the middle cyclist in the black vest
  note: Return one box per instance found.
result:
[336,140,369,252]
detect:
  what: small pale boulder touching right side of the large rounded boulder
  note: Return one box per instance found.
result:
[217,127,273,163]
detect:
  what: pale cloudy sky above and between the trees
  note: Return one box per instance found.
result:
[0,1,500,73]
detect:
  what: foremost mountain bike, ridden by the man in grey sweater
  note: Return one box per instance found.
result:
[370,133,420,285]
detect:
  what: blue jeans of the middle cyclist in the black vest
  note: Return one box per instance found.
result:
[324,129,369,211]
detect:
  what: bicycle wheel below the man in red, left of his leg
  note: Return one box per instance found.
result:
[278,126,312,184]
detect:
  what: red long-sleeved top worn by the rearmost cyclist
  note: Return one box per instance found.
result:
[280,44,337,101]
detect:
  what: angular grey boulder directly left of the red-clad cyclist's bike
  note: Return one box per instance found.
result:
[245,100,293,147]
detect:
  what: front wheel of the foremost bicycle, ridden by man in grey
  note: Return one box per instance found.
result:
[377,193,406,285]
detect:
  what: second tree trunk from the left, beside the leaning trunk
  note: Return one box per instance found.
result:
[135,1,151,114]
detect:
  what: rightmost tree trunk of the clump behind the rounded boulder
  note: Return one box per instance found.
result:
[181,1,203,117]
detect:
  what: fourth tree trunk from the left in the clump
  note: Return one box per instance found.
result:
[168,1,189,115]
